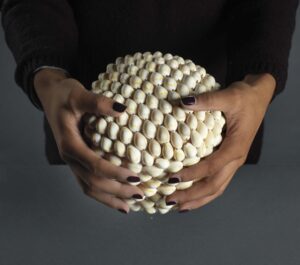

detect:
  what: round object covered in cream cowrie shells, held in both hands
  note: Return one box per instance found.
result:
[84,51,226,214]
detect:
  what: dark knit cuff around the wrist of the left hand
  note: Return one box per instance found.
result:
[15,53,75,111]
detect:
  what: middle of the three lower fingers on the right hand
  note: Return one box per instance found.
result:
[166,159,237,204]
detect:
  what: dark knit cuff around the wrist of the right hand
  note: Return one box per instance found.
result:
[226,60,287,103]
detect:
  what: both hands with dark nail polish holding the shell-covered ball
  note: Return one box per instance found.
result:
[34,69,275,213]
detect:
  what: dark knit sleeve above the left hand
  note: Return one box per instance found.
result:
[0,0,78,110]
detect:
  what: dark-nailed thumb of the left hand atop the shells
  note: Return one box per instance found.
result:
[70,86,127,117]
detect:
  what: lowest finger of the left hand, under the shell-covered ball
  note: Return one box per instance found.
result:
[88,191,130,213]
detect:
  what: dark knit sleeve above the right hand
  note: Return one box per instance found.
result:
[226,0,299,101]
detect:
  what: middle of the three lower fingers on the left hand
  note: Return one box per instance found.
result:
[68,155,145,199]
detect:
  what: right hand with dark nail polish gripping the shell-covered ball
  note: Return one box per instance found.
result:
[166,73,276,212]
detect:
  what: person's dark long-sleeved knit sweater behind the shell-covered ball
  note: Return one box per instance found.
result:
[0,0,298,164]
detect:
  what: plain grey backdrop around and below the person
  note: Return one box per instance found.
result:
[0,6,300,265]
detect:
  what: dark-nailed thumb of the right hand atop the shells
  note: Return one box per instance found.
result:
[181,89,231,111]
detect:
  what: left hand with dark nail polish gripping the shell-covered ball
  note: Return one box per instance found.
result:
[33,69,144,213]
